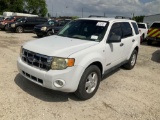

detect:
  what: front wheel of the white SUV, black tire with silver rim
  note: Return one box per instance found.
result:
[75,65,101,100]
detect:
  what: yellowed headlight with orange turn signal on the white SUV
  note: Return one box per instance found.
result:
[51,57,75,70]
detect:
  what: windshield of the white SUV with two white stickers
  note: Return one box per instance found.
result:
[58,20,108,42]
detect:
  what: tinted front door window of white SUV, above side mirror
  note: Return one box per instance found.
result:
[108,23,122,39]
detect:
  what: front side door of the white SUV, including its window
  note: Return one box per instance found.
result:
[105,23,124,70]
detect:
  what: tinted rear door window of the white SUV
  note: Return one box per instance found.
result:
[121,22,133,38]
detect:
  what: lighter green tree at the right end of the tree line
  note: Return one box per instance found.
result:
[24,0,47,17]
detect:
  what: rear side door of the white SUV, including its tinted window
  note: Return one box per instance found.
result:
[121,22,135,60]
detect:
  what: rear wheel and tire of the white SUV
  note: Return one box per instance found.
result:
[124,50,138,70]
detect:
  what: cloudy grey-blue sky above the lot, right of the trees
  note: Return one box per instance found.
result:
[46,0,160,17]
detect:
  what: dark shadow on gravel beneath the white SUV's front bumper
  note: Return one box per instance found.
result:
[14,74,80,102]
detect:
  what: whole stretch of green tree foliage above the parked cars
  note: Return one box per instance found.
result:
[0,0,48,17]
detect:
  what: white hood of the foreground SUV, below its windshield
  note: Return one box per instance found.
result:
[23,35,99,57]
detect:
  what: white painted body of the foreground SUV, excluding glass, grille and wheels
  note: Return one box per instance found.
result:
[17,18,140,92]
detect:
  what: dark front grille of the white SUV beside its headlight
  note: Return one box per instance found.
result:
[22,49,53,71]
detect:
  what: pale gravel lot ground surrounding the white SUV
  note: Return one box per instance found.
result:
[0,31,160,120]
